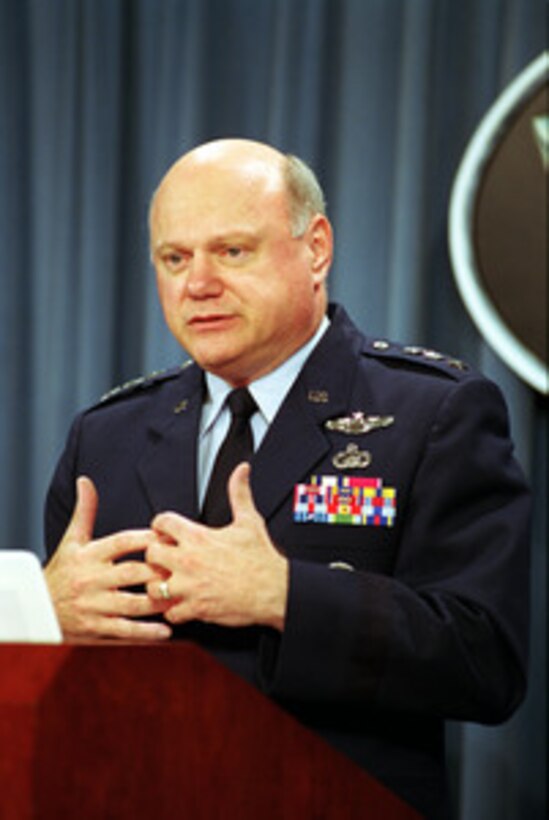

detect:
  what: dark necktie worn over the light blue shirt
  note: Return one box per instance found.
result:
[200,387,257,527]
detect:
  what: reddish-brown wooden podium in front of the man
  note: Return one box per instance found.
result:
[0,643,419,820]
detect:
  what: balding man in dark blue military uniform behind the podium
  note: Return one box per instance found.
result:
[45,140,529,817]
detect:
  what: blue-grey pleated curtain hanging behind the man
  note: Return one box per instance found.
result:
[0,0,547,820]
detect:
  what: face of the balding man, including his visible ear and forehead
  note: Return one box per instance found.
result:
[151,149,331,386]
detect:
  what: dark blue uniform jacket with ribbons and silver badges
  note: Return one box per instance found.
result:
[46,307,529,817]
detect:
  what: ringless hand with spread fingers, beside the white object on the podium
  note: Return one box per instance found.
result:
[44,476,171,641]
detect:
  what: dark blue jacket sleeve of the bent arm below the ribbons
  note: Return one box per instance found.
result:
[262,379,530,723]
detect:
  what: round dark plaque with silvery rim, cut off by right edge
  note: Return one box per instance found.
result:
[449,52,549,394]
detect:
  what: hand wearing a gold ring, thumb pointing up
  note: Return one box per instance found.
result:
[146,464,288,630]
